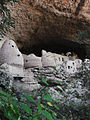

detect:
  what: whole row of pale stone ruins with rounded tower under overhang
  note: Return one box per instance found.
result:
[0,40,90,89]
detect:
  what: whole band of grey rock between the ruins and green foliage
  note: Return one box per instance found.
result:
[0,63,90,106]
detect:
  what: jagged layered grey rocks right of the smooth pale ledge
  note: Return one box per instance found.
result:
[31,65,90,106]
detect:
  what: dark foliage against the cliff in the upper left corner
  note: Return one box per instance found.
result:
[0,0,20,35]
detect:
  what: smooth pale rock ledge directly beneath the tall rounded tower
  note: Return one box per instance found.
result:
[0,64,41,94]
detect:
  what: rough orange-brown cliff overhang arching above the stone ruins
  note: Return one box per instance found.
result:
[10,0,90,56]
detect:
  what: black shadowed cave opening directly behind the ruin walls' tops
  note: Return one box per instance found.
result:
[21,39,86,60]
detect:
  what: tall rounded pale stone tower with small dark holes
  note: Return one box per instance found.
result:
[0,40,24,76]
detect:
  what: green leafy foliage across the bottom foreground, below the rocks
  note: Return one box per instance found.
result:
[0,77,90,120]
